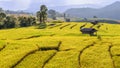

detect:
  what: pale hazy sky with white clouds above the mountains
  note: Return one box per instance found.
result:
[0,0,120,10]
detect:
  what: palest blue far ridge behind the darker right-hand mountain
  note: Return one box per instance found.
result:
[25,2,103,13]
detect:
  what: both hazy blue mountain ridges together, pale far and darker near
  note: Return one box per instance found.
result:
[25,1,120,20]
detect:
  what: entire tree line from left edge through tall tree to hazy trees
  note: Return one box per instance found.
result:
[0,5,69,29]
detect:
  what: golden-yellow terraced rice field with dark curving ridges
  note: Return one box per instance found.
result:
[0,22,120,68]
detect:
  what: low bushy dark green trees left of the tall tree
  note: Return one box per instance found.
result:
[0,12,36,29]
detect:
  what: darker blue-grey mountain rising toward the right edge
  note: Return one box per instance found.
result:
[65,1,120,20]
